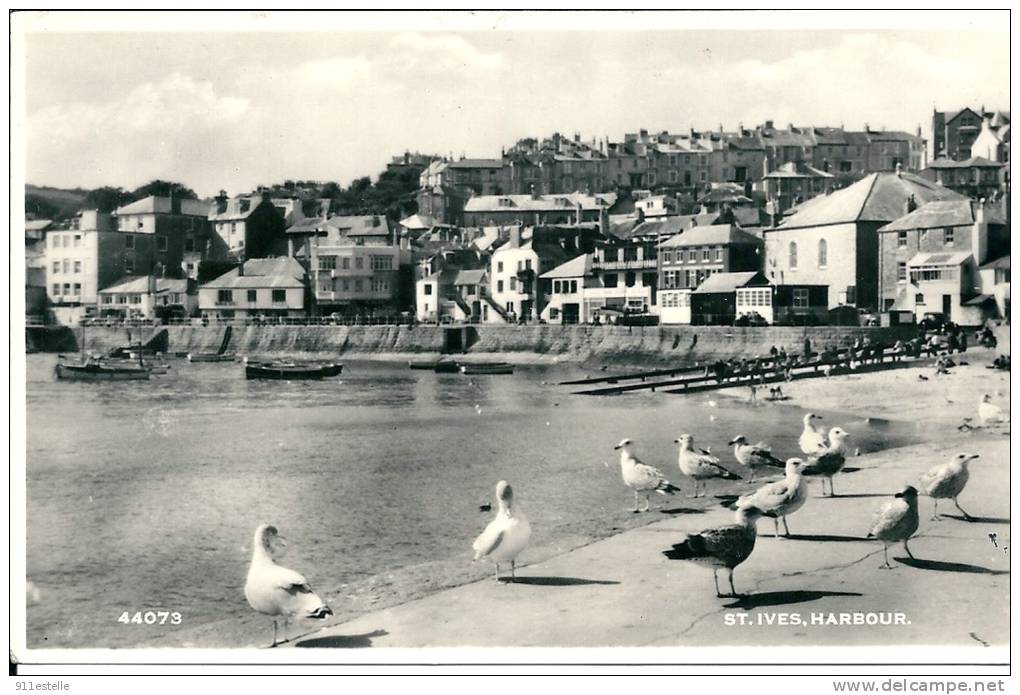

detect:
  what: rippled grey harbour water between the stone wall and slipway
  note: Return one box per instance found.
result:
[27,354,934,647]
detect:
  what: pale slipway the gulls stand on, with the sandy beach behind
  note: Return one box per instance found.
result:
[277,355,1011,661]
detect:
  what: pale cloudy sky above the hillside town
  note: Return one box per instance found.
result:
[17,13,1010,196]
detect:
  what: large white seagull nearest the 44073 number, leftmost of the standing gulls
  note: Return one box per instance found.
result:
[245,524,333,647]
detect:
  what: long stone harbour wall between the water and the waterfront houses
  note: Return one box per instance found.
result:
[59,325,930,364]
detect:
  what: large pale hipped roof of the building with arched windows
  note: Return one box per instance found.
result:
[769,171,966,232]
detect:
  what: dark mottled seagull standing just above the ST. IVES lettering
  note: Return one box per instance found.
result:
[662,505,762,598]
